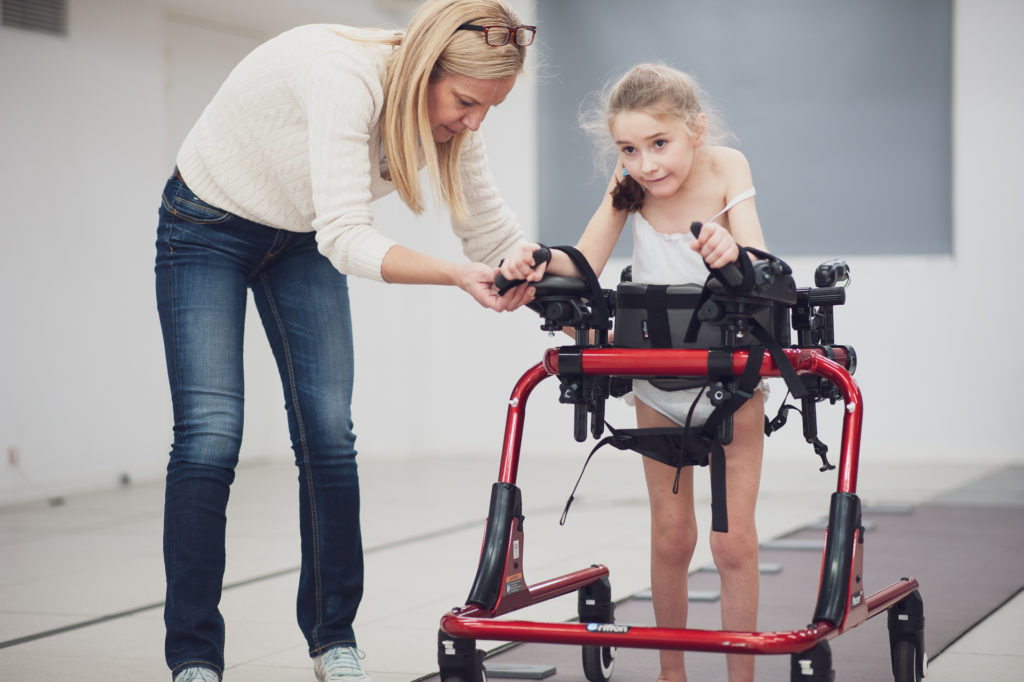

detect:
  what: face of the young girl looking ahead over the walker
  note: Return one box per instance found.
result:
[610,111,707,199]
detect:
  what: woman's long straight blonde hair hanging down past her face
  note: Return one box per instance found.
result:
[352,0,526,217]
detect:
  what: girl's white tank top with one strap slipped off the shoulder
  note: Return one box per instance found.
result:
[633,187,755,284]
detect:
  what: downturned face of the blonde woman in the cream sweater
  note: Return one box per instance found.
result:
[427,74,515,142]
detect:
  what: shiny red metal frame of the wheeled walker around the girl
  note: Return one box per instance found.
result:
[440,346,924,679]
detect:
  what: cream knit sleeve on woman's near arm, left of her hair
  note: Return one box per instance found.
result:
[303,48,395,281]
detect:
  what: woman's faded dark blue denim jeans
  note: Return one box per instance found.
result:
[156,171,362,672]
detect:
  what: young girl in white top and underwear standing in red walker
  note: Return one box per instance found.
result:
[501,65,765,682]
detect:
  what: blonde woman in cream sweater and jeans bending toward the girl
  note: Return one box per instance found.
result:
[156,0,536,682]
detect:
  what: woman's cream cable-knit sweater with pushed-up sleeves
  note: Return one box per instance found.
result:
[177,25,522,281]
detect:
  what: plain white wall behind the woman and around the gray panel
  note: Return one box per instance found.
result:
[0,0,1024,504]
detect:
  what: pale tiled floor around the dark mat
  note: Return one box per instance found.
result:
[0,452,1024,682]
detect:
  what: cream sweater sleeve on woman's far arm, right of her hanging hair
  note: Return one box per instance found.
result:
[452,133,525,266]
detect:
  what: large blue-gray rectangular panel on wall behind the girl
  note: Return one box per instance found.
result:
[538,0,952,255]
